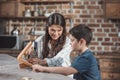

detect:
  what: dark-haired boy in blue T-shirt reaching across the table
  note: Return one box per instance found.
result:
[32,25,101,80]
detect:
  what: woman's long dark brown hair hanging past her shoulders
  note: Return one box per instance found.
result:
[42,13,66,59]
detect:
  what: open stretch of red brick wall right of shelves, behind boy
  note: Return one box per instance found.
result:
[73,0,120,52]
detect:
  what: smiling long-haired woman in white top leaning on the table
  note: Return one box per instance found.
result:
[29,13,71,66]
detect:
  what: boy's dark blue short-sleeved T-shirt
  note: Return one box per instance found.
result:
[71,49,101,80]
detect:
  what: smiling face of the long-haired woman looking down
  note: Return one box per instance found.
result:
[48,25,63,40]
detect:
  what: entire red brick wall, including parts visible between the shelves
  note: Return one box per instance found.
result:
[5,0,120,52]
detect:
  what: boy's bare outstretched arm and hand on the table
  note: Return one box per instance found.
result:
[32,65,78,75]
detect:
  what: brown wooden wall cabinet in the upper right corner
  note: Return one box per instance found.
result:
[104,0,120,19]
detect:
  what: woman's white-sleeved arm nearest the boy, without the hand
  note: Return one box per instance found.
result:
[46,37,71,66]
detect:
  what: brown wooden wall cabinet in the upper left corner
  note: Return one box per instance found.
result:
[0,1,23,17]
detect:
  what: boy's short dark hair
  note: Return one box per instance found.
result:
[69,24,92,45]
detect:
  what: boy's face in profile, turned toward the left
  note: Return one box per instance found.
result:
[69,34,80,50]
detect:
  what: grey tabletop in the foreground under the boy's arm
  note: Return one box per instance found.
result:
[0,54,74,80]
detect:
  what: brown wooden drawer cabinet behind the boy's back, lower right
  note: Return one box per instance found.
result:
[99,58,120,80]
